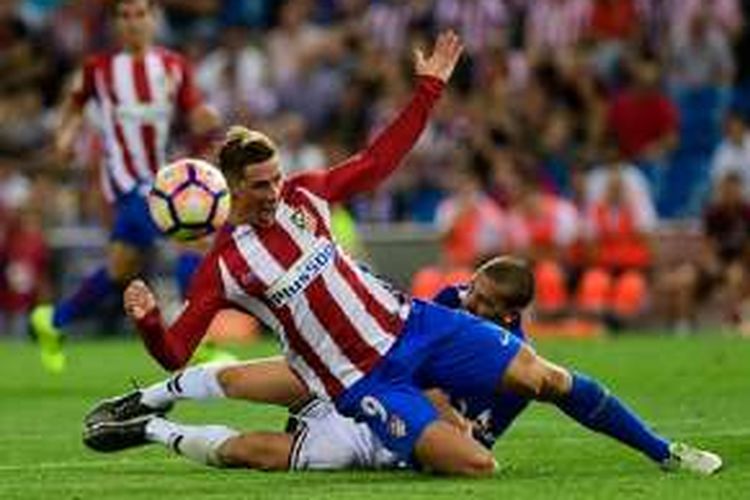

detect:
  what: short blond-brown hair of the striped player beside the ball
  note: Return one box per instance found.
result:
[219,126,276,184]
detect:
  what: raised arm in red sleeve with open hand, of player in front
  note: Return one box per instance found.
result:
[288,31,463,202]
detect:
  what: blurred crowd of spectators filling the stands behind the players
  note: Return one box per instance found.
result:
[0,0,750,336]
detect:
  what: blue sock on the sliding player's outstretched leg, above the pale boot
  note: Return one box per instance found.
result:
[557,373,669,462]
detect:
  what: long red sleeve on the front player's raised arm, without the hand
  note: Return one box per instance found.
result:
[287,76,444,203]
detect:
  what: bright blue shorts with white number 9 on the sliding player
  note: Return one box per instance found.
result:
[335,300,523,460]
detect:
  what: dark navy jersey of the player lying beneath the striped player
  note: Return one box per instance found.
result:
[433,285,529,448]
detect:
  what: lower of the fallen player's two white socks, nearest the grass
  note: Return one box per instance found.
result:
[146,417,239,467]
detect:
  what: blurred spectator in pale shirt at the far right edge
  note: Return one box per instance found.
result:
[711,112,750,197]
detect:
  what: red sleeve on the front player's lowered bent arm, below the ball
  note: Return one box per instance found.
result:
[136,261,233,371]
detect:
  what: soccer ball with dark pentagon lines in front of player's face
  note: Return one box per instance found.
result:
[148,158,230,241]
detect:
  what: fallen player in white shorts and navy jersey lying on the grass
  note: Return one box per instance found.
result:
[84,257,724,473]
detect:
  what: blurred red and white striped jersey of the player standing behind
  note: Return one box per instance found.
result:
[72,47,201,200]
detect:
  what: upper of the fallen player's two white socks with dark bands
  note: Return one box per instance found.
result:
[141,363,233,408]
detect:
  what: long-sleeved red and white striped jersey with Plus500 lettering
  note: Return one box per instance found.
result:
[137,77,443,398]
